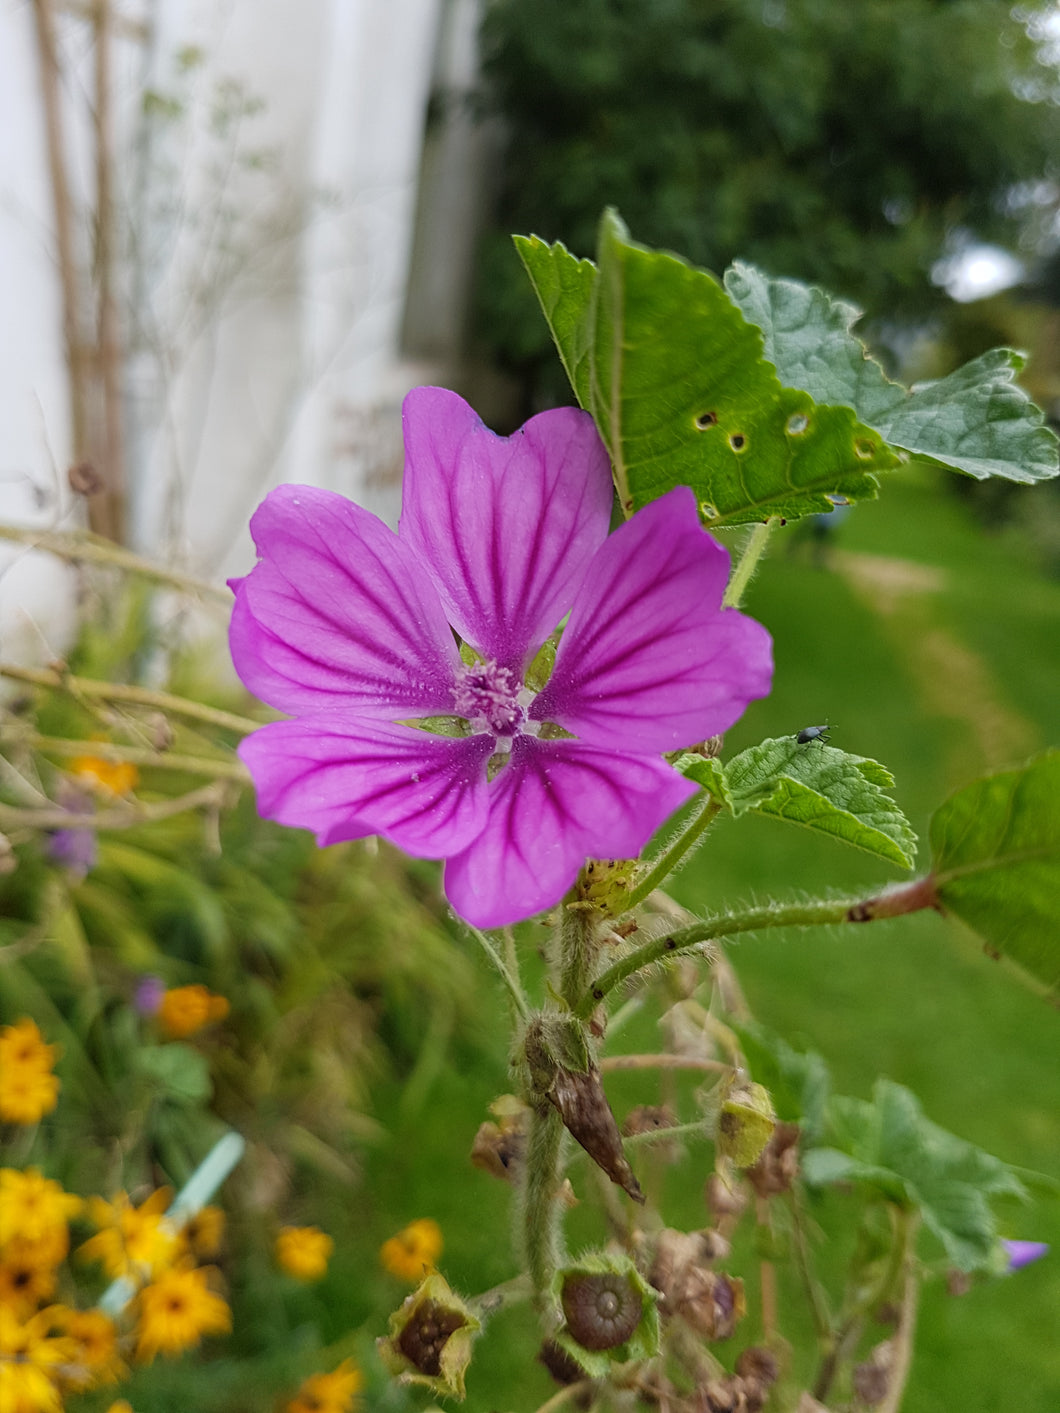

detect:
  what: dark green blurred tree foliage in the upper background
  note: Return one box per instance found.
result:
[478,0,1060,401]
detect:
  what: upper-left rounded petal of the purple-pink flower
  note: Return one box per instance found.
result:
[229,486,459,718]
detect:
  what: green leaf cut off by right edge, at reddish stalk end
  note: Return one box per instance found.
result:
[931,750,1060,995]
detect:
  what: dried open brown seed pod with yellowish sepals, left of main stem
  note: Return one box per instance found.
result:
[377,1270,482,1399]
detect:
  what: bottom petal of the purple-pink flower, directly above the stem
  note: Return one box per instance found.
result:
[445,736,695,927]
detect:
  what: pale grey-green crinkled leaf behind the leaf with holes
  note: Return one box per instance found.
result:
[725,261,1060,483]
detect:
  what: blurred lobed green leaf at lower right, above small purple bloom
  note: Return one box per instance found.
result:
[803,1080,1026,1270]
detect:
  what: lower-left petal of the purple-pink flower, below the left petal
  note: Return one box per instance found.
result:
[239,712,493,859]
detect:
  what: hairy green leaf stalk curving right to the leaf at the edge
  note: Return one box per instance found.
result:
[574,876,937,1017]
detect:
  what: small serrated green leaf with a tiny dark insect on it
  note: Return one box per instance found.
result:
[725,736,916,869]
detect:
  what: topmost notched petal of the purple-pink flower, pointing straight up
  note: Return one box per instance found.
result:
[399,387,612,671]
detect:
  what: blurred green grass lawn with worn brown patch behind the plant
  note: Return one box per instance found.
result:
[310,473,1060,1413]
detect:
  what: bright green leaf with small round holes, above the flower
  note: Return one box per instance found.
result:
[519,212,897,527]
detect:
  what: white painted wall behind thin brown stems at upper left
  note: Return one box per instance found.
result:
[0,0,475,660]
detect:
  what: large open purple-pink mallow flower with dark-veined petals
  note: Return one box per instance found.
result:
[230,387,772,927]
